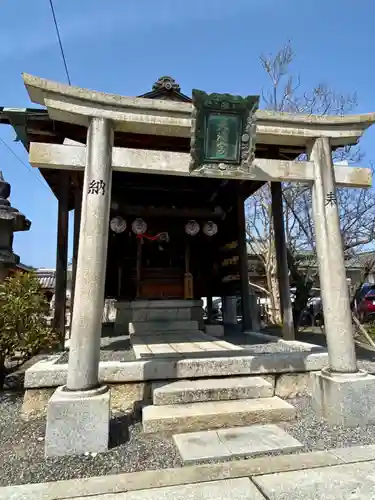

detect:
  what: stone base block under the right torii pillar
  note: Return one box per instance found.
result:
[311,369,375,427]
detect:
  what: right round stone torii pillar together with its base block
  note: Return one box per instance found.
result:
[310,137,375,427]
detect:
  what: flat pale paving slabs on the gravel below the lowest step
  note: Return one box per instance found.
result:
[173,424,303,464]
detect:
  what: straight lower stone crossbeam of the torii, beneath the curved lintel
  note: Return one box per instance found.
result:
[29,143,372,187]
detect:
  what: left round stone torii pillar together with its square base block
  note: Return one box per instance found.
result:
[45,118,113,456]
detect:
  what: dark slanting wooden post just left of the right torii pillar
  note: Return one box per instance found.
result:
[271,182,295,340]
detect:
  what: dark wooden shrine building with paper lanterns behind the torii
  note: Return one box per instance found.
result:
[0,77,276,329]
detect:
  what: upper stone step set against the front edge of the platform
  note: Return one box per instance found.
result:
[152,377,273,406]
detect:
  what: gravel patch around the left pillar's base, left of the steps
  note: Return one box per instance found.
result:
[0,393,181,486]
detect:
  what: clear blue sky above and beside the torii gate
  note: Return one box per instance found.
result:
[0,0,375,267]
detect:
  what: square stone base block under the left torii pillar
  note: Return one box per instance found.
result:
[45,386,110,457]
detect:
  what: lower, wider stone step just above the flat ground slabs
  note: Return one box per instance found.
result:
[143,396,296,433]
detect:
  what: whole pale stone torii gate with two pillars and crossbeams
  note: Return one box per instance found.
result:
[18,75,375,454]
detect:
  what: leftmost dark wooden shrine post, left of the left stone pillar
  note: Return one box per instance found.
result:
[53,170,70,349]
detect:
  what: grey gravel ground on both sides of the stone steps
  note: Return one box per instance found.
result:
[0,393,375,486]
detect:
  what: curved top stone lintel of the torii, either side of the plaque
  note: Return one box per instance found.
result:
[23,74,375,147]
